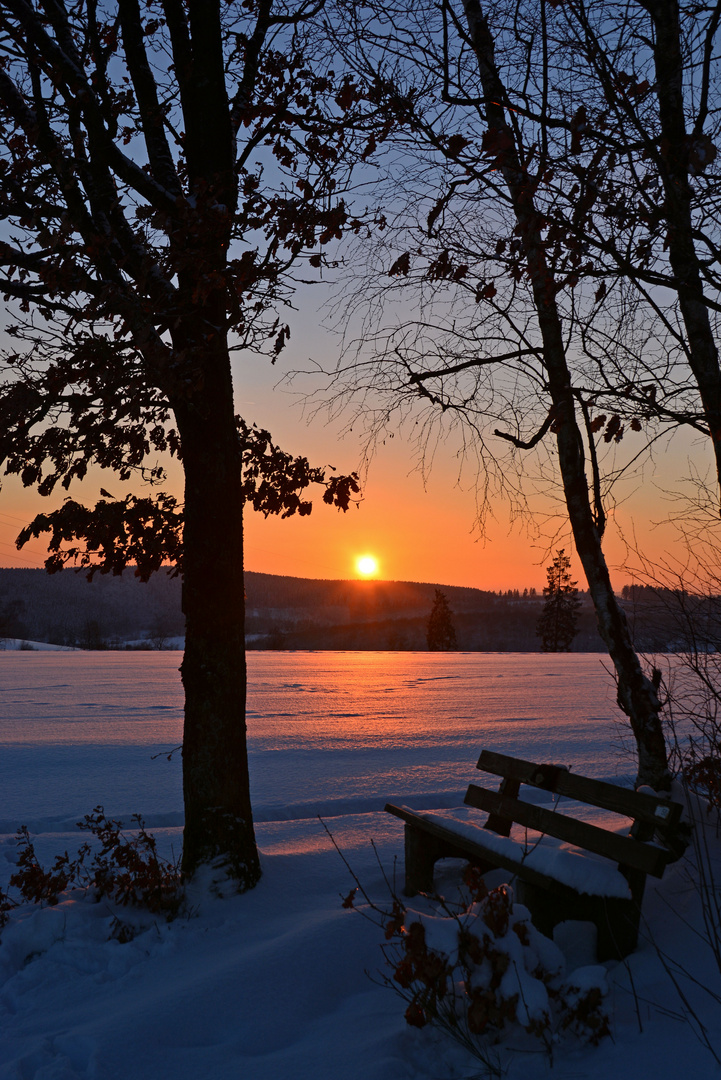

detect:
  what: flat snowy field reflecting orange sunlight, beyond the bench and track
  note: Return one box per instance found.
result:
[0,651,635,833]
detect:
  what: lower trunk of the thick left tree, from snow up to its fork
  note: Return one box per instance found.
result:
[175,335,260,890]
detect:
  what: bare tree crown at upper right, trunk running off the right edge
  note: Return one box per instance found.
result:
[518,0,721,494]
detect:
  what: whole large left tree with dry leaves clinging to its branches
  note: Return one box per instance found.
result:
[0,0,368,889]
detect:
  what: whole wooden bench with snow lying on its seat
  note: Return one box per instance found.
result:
[385,751,684,960]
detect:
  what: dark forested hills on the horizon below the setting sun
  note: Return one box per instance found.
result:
[0,568,721,652]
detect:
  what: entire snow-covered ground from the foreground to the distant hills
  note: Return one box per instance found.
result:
[0,651,721,1080]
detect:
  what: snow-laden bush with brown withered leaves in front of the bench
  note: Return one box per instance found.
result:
[343,867,610,1076]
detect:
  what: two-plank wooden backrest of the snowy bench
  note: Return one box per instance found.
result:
[465,751,682,877]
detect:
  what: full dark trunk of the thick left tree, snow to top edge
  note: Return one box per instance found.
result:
[165,2,262,890]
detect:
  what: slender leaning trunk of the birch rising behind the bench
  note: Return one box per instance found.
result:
[464,0,670,789]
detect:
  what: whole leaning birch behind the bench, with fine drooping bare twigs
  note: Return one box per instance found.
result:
[317,0,695,787]
